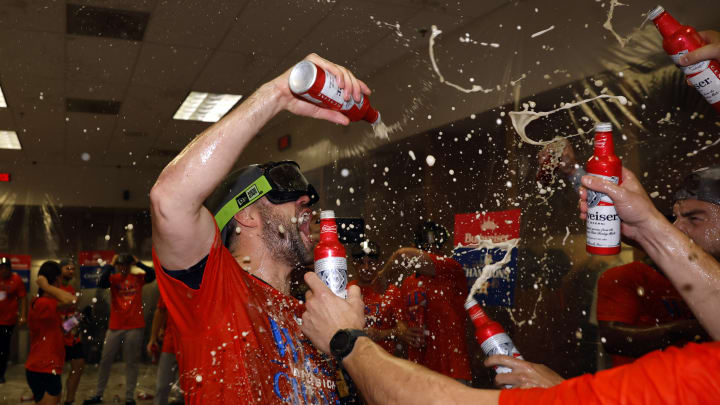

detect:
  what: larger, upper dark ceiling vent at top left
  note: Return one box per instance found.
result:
[66,4,150,41]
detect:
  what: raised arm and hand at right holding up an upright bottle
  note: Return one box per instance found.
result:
[580,168,720,340]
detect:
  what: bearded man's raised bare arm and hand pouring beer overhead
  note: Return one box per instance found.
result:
[150,54,370,270]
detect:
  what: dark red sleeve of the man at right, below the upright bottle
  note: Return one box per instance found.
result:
[597,266,640,324]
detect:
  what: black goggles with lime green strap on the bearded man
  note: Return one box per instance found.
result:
[215,160,320,229]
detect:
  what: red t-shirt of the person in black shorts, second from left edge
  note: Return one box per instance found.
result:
[25,296,65,375]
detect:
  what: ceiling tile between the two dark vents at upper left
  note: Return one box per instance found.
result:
[65,36,141,83]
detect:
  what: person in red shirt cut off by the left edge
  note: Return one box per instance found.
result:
[0,257,27,384]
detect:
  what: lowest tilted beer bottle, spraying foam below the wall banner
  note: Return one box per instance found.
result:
[465,298,522,388]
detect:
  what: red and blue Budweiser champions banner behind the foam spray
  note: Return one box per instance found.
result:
[453,209,521,307]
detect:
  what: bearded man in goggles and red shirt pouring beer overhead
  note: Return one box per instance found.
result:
[150,54,370,404]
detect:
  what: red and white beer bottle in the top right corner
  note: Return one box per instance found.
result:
[648,6,720,112]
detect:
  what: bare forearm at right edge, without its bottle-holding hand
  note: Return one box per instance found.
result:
[638,219,720,339]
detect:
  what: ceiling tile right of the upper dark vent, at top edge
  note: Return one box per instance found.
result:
[145,0,250,48]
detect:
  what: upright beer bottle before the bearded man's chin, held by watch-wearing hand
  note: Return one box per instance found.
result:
[315,211,347,298]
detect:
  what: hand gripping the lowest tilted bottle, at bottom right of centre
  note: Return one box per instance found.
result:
[484,355,565,388]
